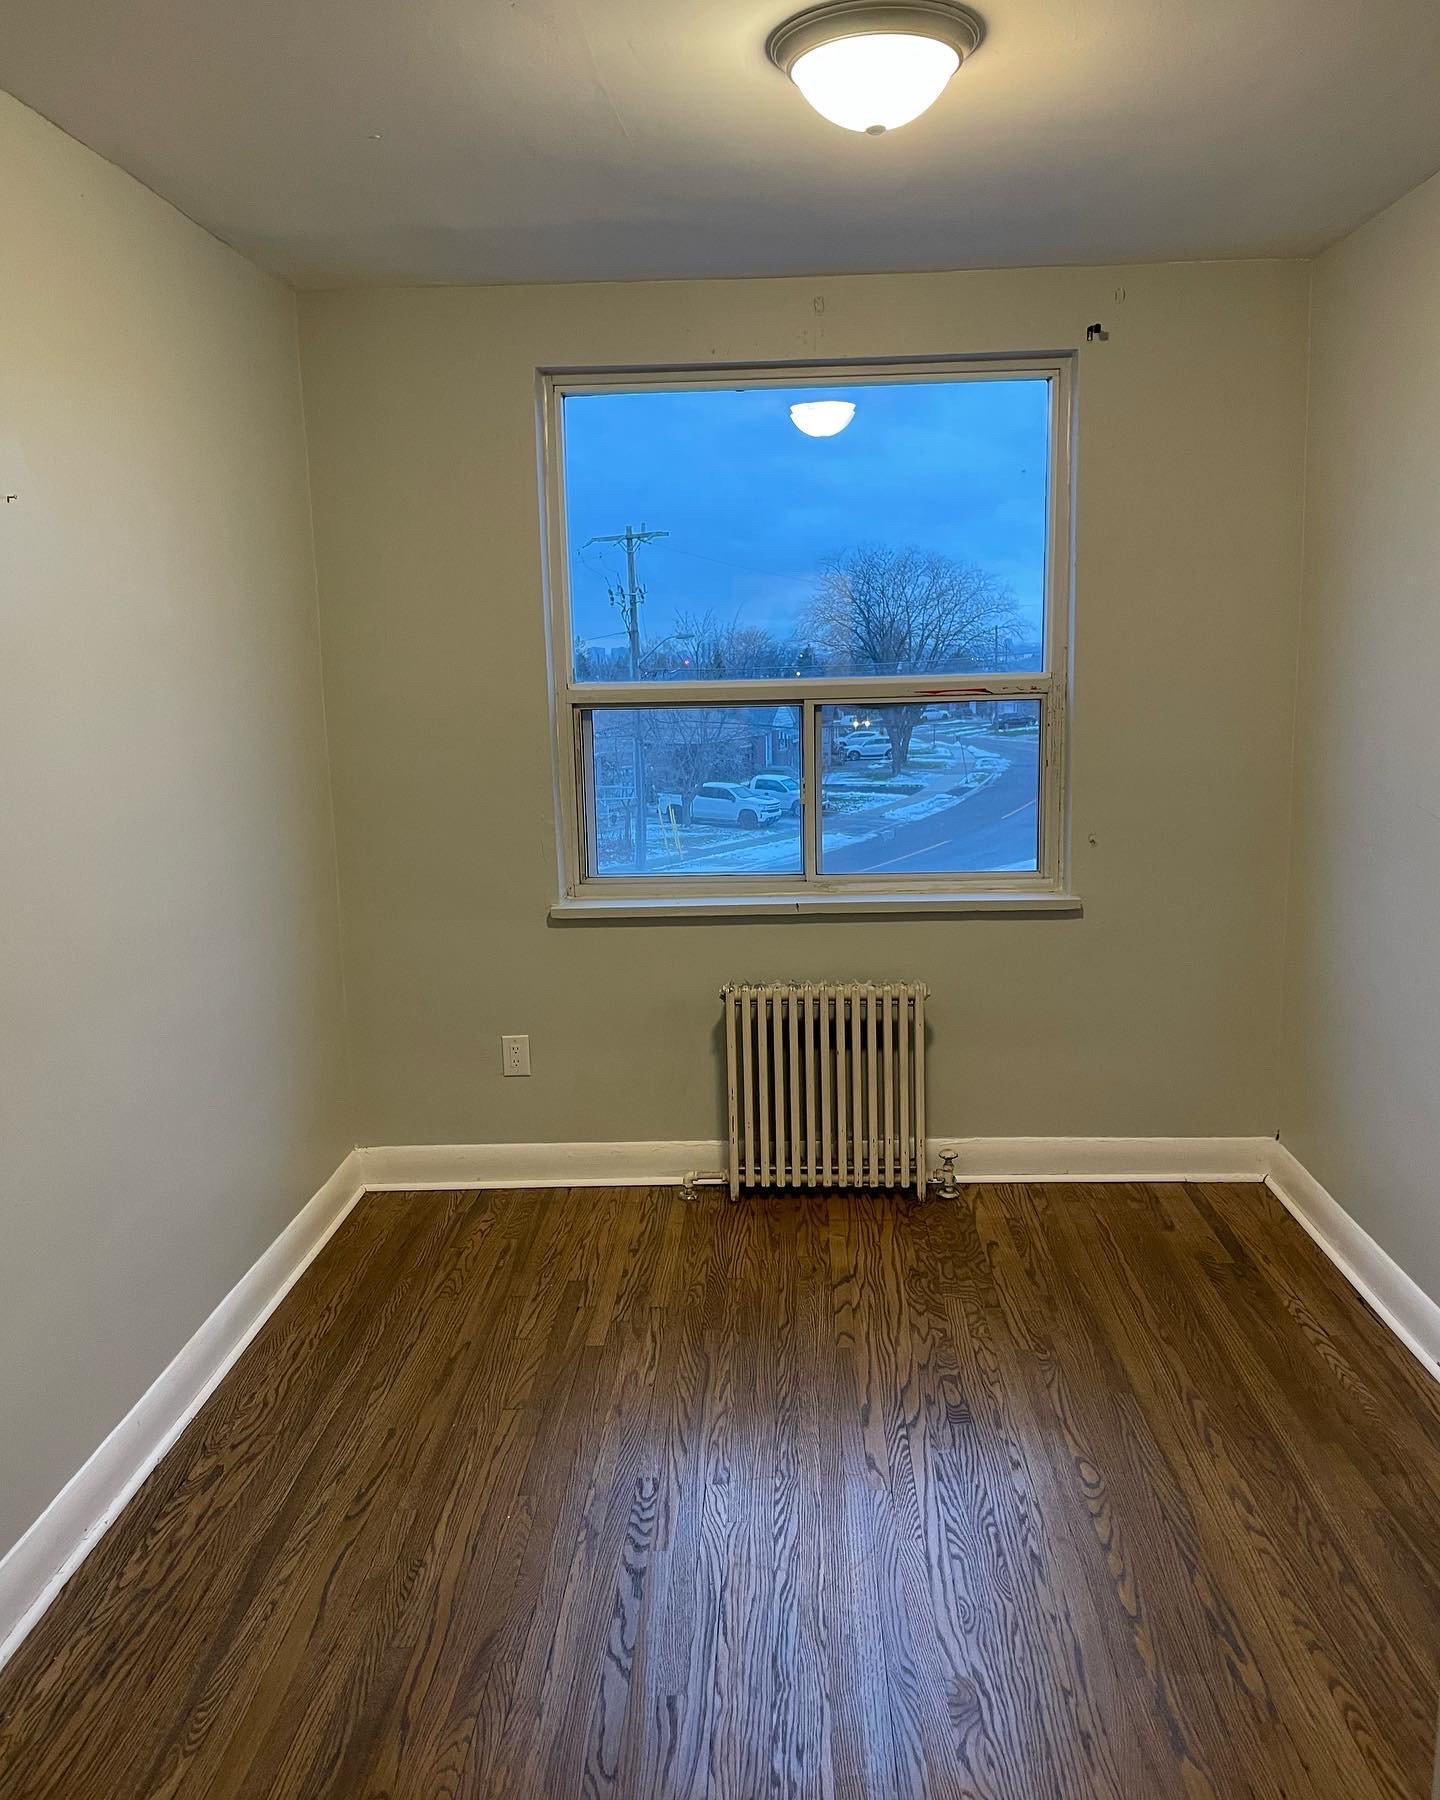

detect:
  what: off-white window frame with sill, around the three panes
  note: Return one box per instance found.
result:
[538,353,1078,916]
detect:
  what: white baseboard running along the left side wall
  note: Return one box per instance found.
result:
[0,1152,364,1667]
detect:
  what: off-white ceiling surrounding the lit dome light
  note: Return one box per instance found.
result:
[0,0,1440,286]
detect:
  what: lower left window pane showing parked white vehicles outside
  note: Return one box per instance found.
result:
[587,706,803,877]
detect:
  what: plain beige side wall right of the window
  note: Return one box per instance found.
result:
[1280,178,1440,1298]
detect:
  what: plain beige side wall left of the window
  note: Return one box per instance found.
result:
[0,95,353,1550]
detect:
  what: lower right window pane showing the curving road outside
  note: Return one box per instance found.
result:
[821,700,1040,877]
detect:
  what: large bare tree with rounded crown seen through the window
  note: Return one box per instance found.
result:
[806,544,1015,770]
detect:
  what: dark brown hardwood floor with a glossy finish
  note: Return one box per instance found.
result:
[0,1186,1440,1800]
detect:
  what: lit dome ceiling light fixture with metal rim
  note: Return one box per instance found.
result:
[765,0,985,137]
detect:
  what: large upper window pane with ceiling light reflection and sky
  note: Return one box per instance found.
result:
[563,376,1049,680]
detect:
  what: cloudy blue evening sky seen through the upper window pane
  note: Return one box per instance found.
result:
[565,376,1049,666]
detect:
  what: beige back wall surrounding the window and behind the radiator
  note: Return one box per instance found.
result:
[301,263,1307,1143]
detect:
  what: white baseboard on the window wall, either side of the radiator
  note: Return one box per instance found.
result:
[360,1138,1273,1190]
